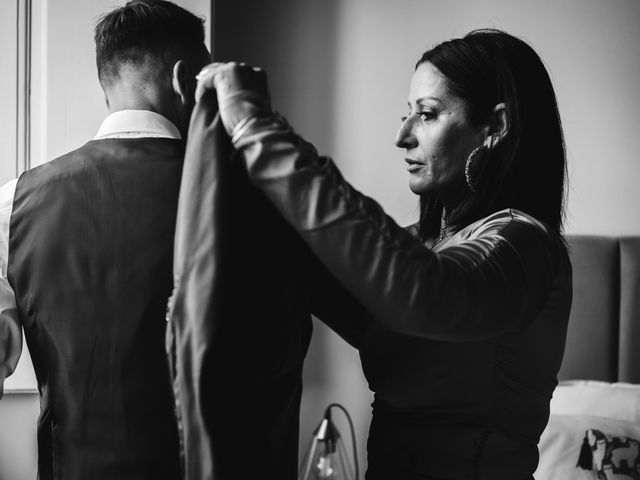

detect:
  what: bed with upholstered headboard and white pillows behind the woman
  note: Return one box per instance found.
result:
[536,235,640,480]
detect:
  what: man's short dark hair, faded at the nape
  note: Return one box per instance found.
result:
[94,0,205,86]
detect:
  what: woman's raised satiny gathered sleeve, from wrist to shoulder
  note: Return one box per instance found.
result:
[234,115,561,341]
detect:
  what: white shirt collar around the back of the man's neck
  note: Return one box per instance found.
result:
[93,110,182,140]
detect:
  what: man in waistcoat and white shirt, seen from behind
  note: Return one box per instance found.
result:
[0,0,210,480]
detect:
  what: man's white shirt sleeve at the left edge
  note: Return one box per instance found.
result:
[0,180,22,398]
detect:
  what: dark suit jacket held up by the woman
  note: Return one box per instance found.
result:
[167,92,311,480]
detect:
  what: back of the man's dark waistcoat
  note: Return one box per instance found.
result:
[8,138,184,480]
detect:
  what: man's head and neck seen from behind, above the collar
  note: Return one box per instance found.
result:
[95,0,211,137]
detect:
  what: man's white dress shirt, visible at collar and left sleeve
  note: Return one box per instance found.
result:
[0,110,182,398]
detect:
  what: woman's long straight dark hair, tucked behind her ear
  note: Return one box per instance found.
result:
[416,30,567,239]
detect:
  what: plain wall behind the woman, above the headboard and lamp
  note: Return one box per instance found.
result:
[214,0,640,472]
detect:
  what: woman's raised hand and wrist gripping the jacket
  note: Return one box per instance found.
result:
[196,62,271,138]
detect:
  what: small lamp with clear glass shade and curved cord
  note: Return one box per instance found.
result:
[298,403,360,480]
